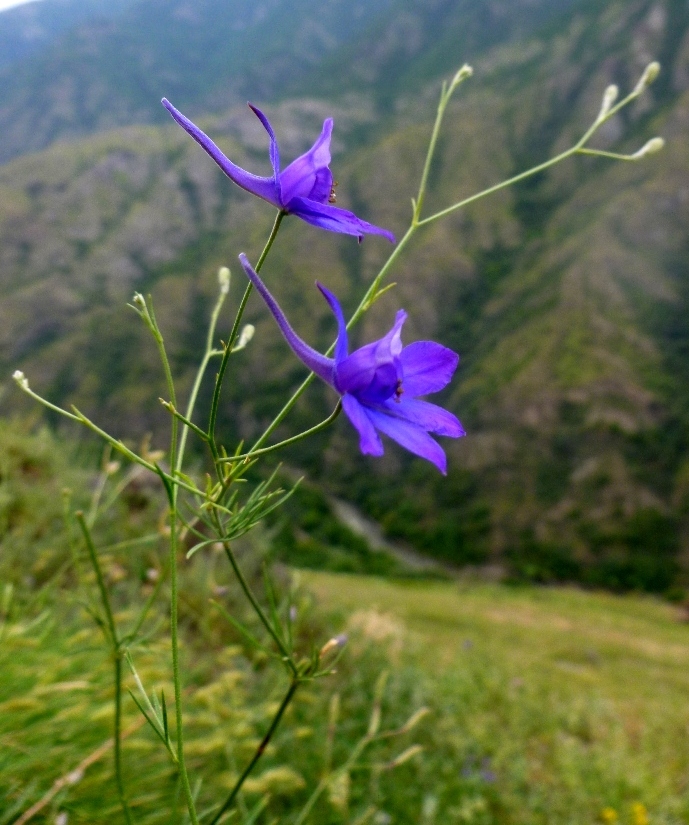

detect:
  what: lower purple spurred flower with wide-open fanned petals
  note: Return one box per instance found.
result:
[239,254,465,474]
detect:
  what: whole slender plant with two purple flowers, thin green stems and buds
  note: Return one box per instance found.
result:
[14,63,663,825]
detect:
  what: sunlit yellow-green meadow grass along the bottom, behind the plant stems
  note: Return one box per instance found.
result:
[0,544,689,825]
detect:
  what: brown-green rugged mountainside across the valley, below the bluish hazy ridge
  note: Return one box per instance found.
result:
[0,0,689,591]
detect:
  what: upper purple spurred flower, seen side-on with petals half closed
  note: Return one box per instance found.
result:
[162,98,395,243]
